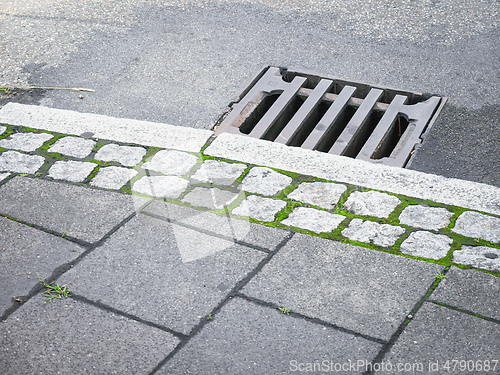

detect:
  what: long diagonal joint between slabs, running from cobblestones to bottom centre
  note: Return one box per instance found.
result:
[146,232,294,375]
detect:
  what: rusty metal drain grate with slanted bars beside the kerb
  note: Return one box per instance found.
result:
[216,67,446,167]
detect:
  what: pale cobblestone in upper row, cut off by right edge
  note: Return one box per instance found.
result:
[452,211,500,242]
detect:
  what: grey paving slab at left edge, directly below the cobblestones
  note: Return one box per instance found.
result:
[0,177,135,242]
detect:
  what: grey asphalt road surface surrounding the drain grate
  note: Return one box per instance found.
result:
[0,0,500,186]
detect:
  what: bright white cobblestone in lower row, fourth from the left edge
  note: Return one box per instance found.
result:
[132,176,189,199]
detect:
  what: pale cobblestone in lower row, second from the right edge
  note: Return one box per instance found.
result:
[400,230,453,259]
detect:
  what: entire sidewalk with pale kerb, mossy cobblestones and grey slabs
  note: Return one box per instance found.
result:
[0,103,500,374]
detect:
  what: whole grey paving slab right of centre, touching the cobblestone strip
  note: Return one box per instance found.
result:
[243,234,443,340]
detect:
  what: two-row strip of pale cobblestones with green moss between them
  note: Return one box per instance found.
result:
[0,125,500,273]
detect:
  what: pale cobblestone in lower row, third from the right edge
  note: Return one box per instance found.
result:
[342,219,405,247]
